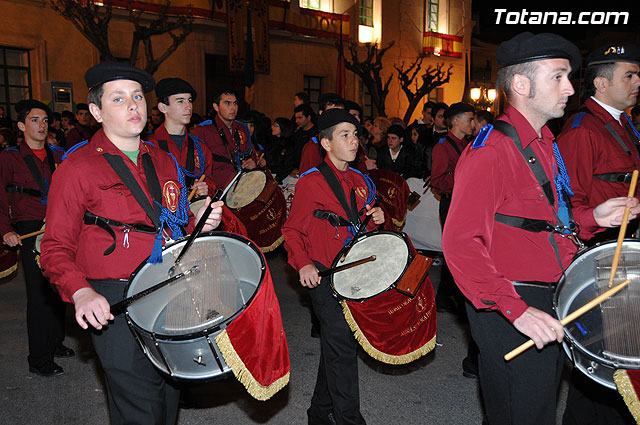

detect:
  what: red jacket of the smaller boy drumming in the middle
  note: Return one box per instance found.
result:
[282,158,377,270]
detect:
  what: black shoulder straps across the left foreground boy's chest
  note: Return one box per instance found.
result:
[103,153,162,229]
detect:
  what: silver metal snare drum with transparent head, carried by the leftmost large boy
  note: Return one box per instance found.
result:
[125,232,266,380]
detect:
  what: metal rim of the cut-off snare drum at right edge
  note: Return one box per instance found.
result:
[553,238,640,372]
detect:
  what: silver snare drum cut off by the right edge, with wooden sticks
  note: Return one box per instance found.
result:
[554,240,640,389]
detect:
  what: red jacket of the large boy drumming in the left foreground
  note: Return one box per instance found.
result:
[40,130,194,302]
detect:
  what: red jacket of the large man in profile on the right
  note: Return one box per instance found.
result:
[442,106,600,323]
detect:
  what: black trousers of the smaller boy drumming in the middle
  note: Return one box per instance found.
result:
[307,264,365,425]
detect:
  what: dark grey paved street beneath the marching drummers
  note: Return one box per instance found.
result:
[0,250,563,425]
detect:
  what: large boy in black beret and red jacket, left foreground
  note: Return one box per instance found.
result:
[41,62,222,424]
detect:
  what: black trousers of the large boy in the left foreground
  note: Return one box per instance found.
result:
[89,280,180,425]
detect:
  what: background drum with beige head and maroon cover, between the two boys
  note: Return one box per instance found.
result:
[224,169,287,252]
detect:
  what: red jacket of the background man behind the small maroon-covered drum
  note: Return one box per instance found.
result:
[191,116,258,188]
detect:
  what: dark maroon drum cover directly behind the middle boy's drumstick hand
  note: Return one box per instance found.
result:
[368,169,410,231]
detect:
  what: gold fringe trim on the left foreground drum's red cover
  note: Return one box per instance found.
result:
[216,330,289,401]
